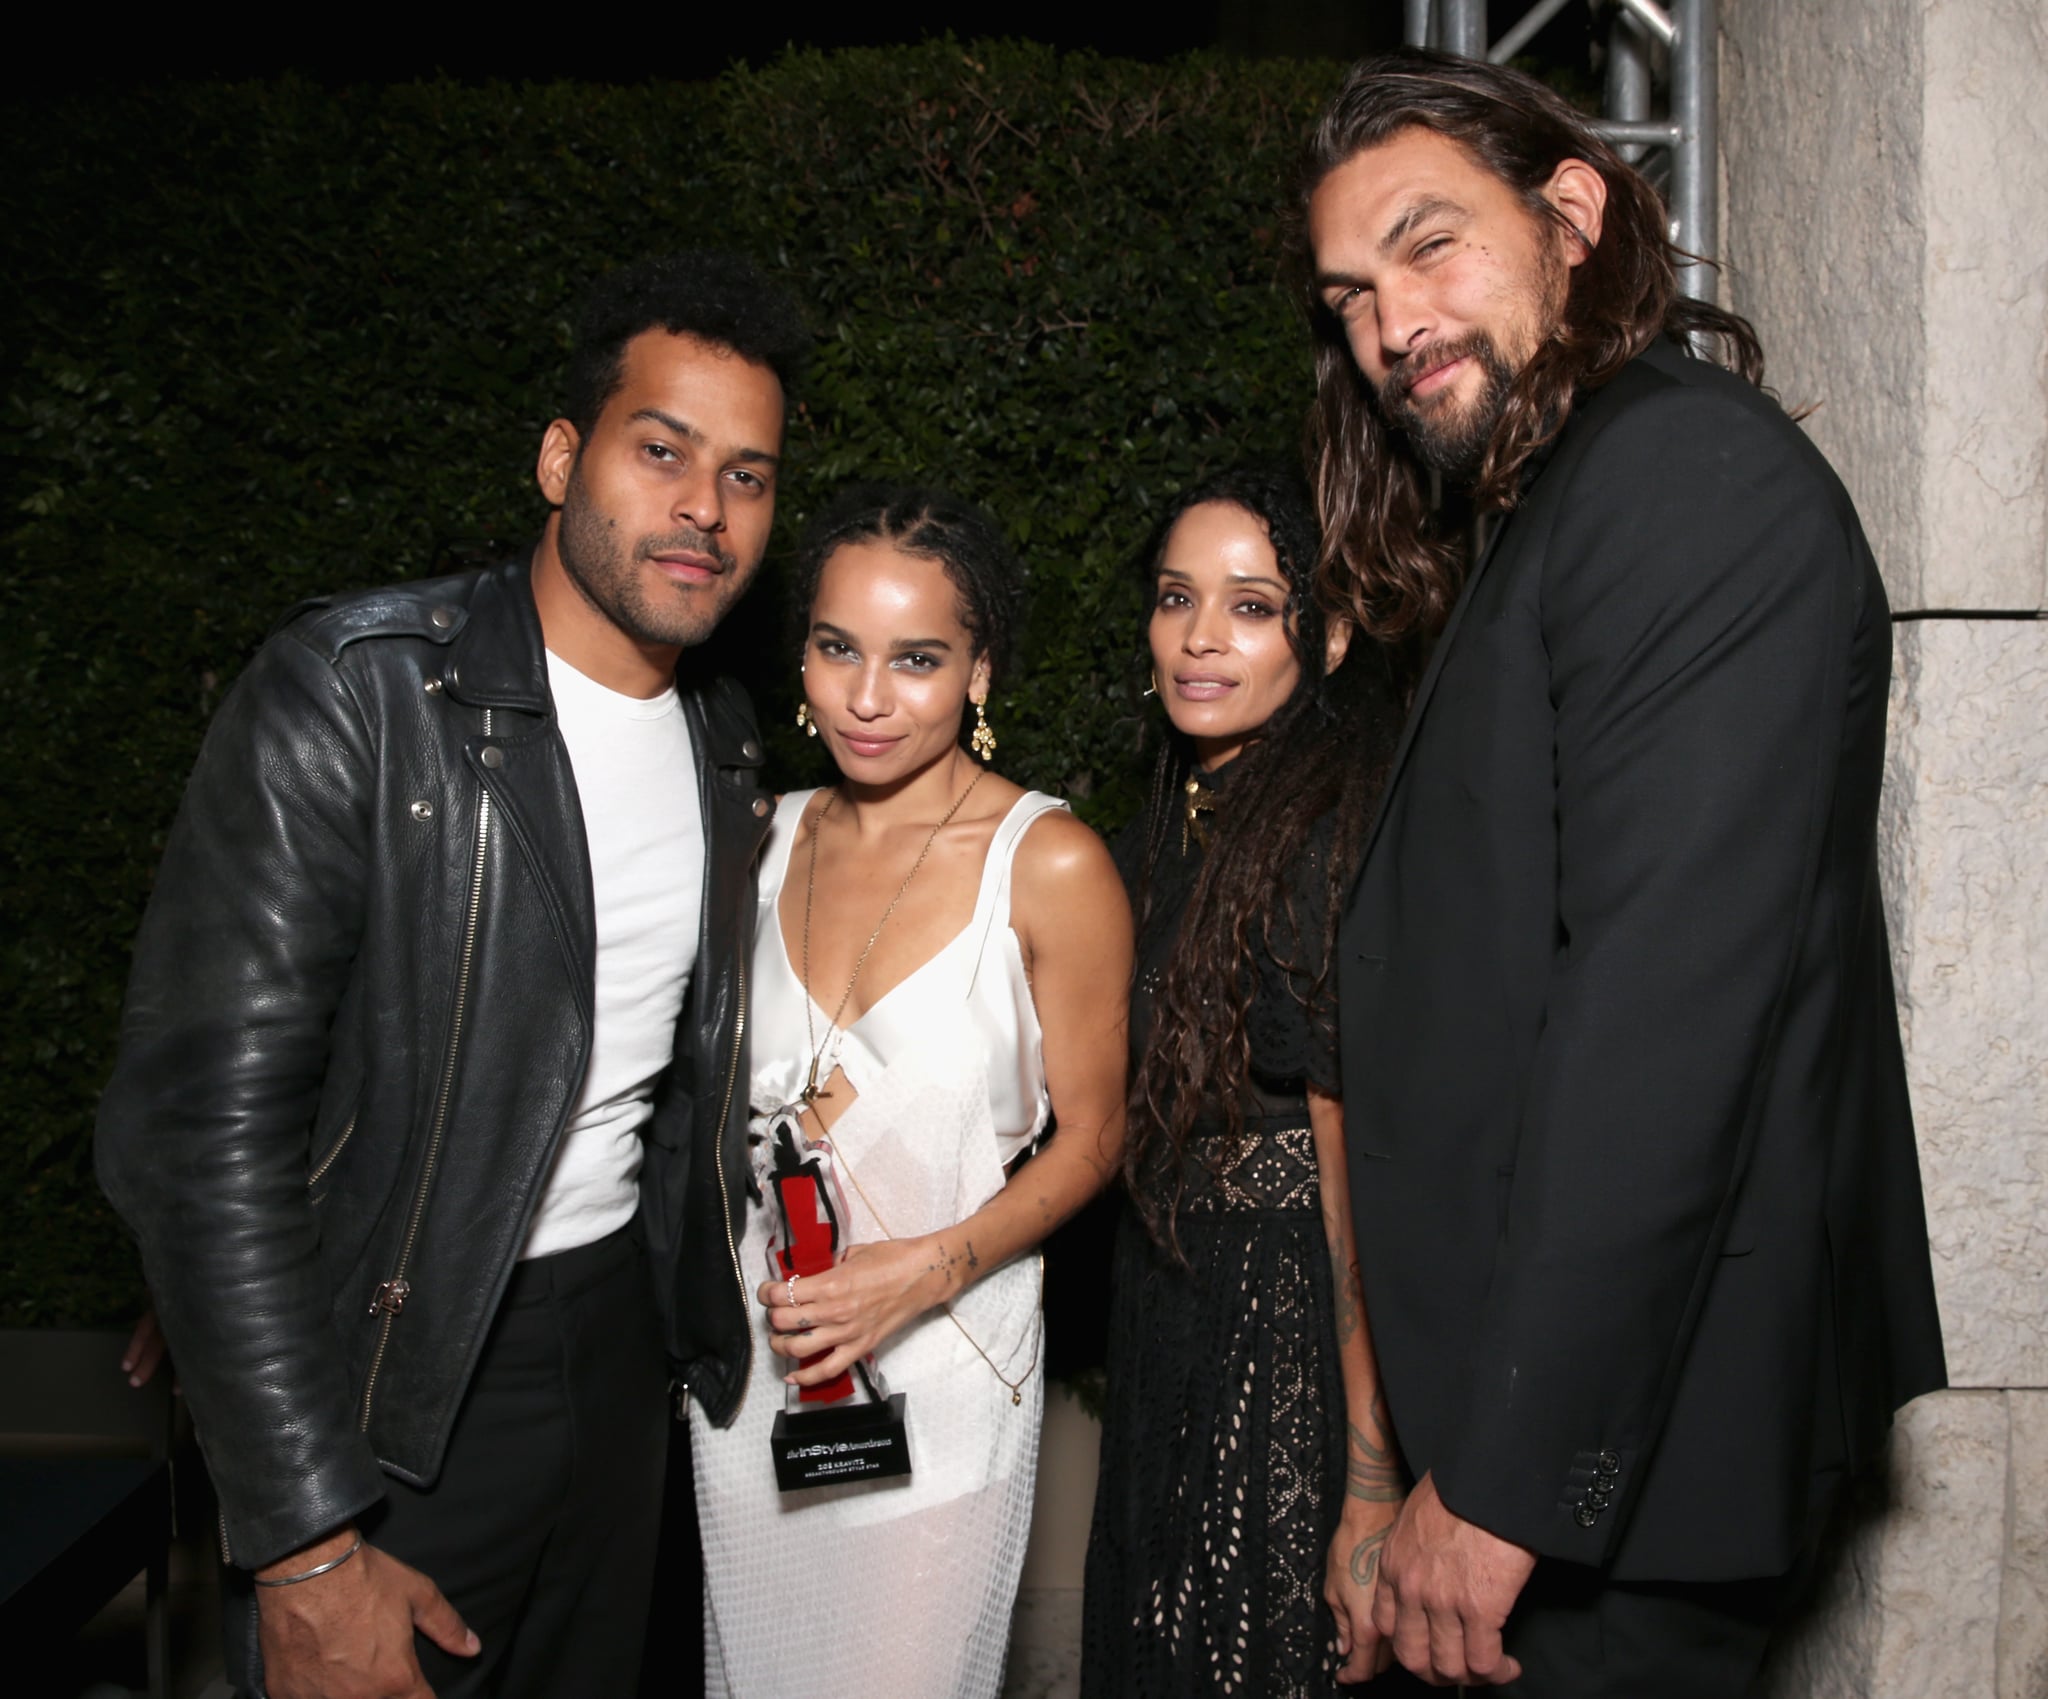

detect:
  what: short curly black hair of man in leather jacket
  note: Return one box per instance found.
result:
[563,252,811,438]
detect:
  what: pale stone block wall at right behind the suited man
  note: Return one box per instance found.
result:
[1720,0,2048,1699]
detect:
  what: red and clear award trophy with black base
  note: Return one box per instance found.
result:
[768,1114,909,1492]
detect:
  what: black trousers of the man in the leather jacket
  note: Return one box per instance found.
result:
[233,1230,668,1699]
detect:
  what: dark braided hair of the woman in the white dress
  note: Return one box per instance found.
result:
[791,483,1024,682]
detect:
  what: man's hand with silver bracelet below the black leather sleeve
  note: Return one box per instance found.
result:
[256,1529,483,1699]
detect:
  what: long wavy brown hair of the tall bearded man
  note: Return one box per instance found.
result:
[1288,49,1763,655]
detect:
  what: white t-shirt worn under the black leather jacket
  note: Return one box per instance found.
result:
[520,653,705,1257]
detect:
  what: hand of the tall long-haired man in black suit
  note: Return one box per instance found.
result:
[1372,1476,1536,1687]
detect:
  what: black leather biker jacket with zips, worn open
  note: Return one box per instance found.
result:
[98,563,772,1566]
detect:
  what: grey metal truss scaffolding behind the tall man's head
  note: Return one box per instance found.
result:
[1403,0,1720,299]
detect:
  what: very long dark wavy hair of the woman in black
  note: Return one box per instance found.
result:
[1124,467,1399,1249]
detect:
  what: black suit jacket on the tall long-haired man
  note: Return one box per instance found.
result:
[1339,344,1944,1580]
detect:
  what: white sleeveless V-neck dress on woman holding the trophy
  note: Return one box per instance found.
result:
[690,792,1065,1699]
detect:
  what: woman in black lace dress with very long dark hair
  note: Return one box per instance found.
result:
[1081,471,1405,1699]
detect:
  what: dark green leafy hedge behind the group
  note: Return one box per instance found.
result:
[0,43,1335,1324]
